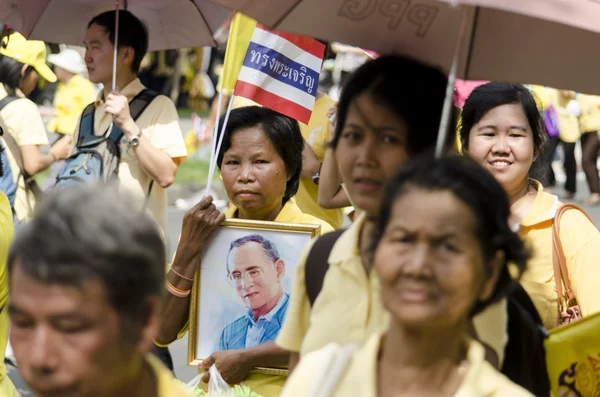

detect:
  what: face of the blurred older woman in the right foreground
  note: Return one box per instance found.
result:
[374,188,497,329]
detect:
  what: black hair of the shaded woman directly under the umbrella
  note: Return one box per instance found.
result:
[331,55,452,155]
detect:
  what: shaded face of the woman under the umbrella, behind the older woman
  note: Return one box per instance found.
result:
[335,94,409,216]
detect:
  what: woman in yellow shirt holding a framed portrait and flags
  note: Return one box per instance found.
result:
[156,106,333,397]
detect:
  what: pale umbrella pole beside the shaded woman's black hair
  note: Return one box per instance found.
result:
[435,8,470,158]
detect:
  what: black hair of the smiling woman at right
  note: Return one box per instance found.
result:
[460,83,547,153]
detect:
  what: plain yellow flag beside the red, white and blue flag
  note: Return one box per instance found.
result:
[218,12,256,90]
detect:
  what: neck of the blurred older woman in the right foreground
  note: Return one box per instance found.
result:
[377,323,466,395]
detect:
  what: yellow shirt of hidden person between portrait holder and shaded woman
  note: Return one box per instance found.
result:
[295,95,344,229]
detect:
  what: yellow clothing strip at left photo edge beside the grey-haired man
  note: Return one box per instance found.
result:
[0,192,17,397]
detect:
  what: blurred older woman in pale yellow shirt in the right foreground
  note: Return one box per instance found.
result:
[282,156,531,397]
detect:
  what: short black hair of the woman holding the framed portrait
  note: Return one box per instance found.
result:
[215,106,304,204]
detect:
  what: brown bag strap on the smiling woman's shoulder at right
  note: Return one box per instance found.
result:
[552,204,594,313]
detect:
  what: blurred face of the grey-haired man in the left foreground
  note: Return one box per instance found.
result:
[9,263,143,397]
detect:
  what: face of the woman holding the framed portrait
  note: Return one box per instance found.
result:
[221,127,290,219]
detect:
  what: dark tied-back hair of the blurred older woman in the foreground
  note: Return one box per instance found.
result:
[372,155,529,314]
